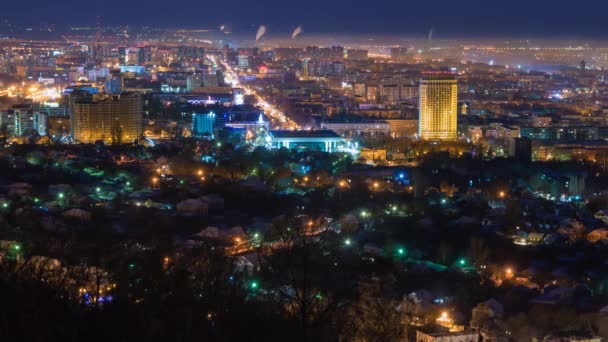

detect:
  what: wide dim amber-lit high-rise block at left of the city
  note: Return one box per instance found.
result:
[70,93,142,144]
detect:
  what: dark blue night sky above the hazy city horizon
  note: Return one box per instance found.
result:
[0,0,608,38]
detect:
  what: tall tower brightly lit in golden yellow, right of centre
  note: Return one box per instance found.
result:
[418,71,458,140]
